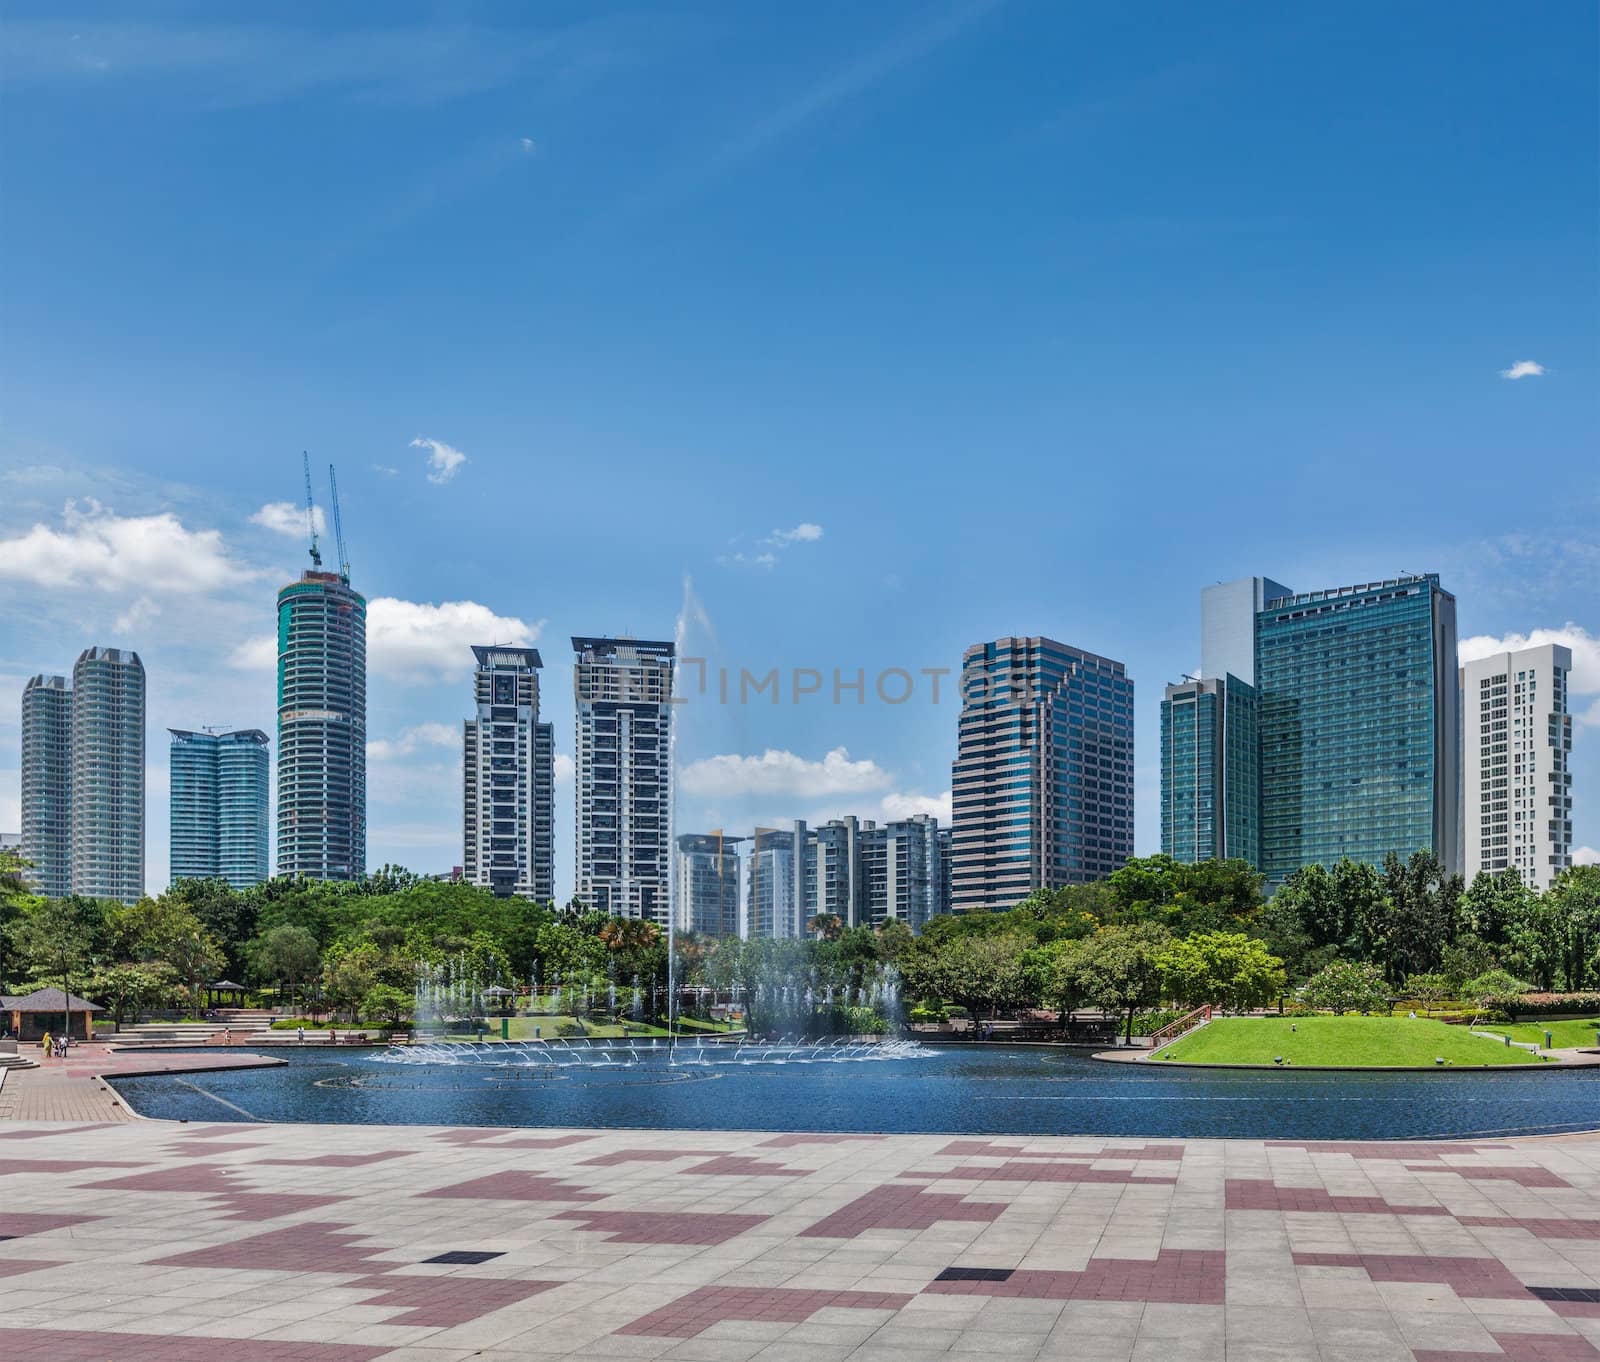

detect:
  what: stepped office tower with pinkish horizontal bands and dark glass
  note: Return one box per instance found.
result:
[950,637,1133,912]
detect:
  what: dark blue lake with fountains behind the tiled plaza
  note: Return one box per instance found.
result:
[117,1042,1600,1140]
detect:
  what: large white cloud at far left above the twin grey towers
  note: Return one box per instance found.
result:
[0,498,259,594]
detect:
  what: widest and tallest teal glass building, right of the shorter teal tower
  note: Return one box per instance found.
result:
[1256,575,1462,883]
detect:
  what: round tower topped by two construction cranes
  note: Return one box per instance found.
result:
[278,571,366,880]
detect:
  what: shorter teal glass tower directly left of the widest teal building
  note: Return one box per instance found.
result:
[1162,672,1261,866]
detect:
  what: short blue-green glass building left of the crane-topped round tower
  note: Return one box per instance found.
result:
[166,728,272,890]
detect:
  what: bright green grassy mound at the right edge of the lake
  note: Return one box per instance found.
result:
[1155,1016,1533,1068]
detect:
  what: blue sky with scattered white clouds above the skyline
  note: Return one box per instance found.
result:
[0,0,1600,891]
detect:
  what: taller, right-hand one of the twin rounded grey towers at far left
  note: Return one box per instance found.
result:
[70,648,144,903]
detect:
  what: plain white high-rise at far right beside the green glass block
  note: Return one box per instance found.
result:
[1461,643,1573,890]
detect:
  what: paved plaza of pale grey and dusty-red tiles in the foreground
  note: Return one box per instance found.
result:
[0,1120,1600,1362]
